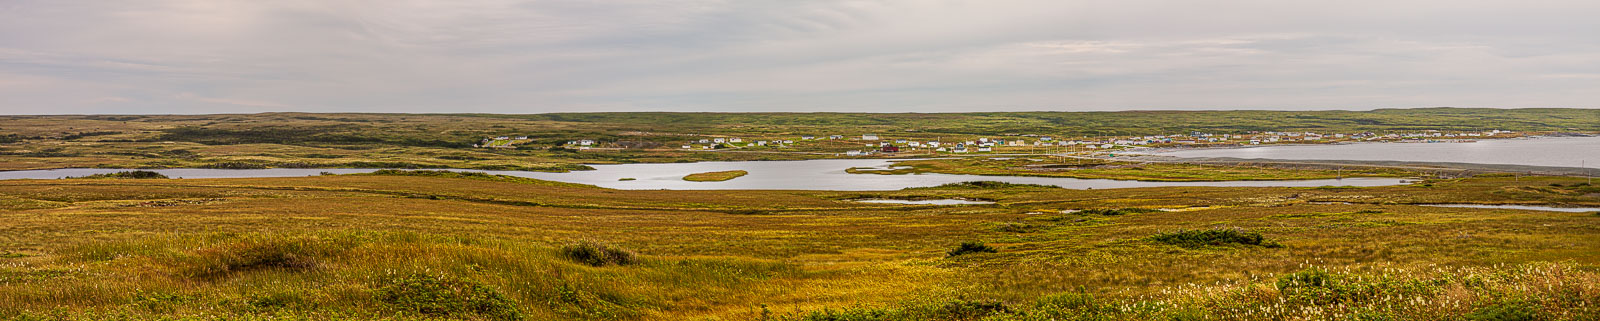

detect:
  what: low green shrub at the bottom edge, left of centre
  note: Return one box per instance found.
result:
[373,275,523,319]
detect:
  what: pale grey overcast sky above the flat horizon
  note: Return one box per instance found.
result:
[0,0,1600,115]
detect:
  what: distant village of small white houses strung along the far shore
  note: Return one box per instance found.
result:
[472,129,1523,157]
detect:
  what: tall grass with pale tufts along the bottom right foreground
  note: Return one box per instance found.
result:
[778,264,1600,321]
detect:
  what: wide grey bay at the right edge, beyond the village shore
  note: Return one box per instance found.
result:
[1155,137,1600,168]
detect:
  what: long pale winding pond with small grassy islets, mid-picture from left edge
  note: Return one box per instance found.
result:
[0,160,1405,190]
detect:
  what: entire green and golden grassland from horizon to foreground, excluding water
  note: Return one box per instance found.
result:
[0,109,1600,321]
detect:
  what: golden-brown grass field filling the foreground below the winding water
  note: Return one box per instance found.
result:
[0,171,1600,319]
